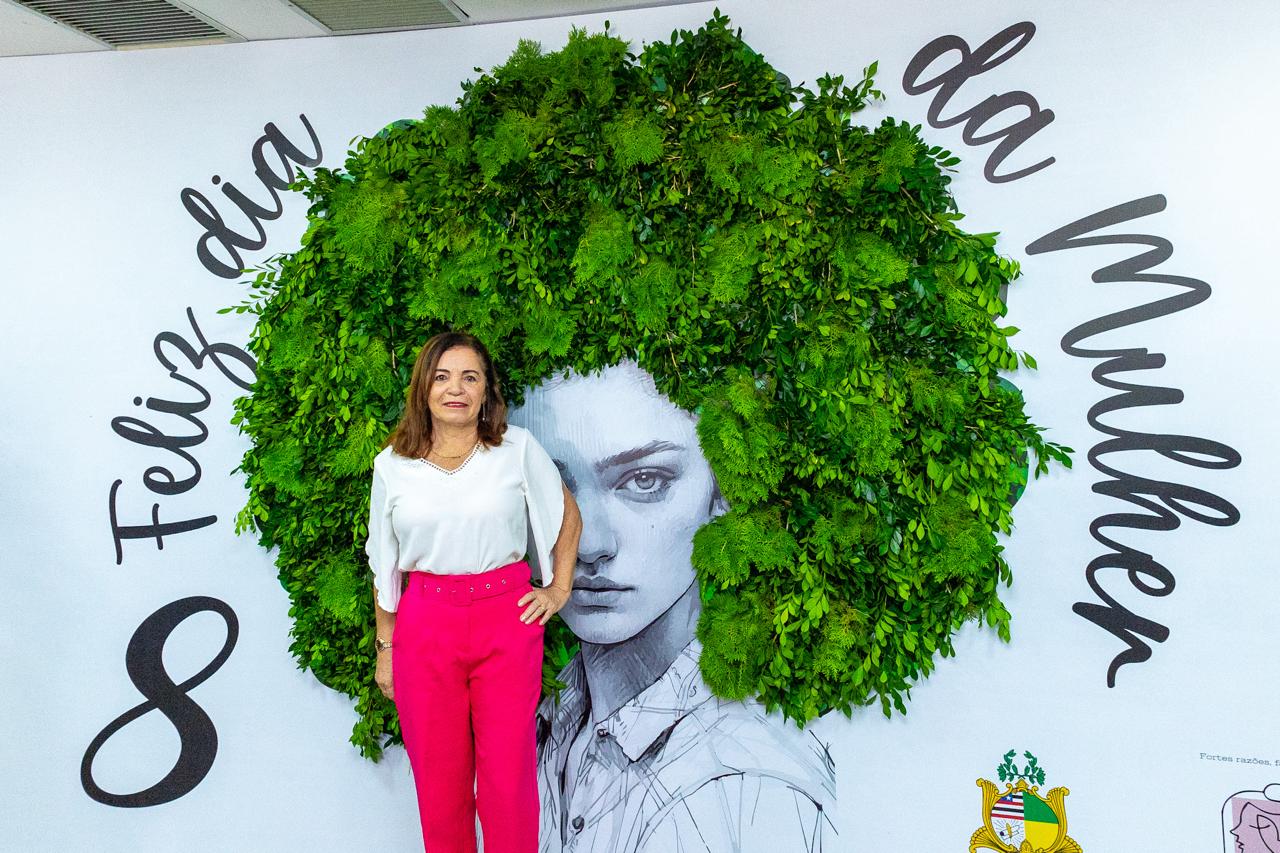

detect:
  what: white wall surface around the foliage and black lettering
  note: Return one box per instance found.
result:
[0,0,1280,850]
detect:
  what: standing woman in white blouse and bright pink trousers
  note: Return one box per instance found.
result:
[366,332,581,853]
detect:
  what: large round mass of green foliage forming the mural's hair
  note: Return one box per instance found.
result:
[227,14,1066,757]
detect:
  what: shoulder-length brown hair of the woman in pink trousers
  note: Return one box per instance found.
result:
[387,332,507,457]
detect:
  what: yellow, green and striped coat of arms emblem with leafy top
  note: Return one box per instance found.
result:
[969,749,1083,853]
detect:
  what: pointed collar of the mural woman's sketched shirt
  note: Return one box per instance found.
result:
[538,638,713,761]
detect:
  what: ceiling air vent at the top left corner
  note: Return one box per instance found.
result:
[18,0,238,47]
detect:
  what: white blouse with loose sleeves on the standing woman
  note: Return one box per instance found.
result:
[365,424,564,612]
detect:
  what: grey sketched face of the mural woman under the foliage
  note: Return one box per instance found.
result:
[511,362,719,643]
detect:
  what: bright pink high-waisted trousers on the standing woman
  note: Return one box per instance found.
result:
[392,561,543,853]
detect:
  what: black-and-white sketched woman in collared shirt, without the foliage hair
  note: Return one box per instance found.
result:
[512,361,836,853]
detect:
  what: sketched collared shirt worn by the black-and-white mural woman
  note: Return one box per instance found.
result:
[538,639,836,853]
